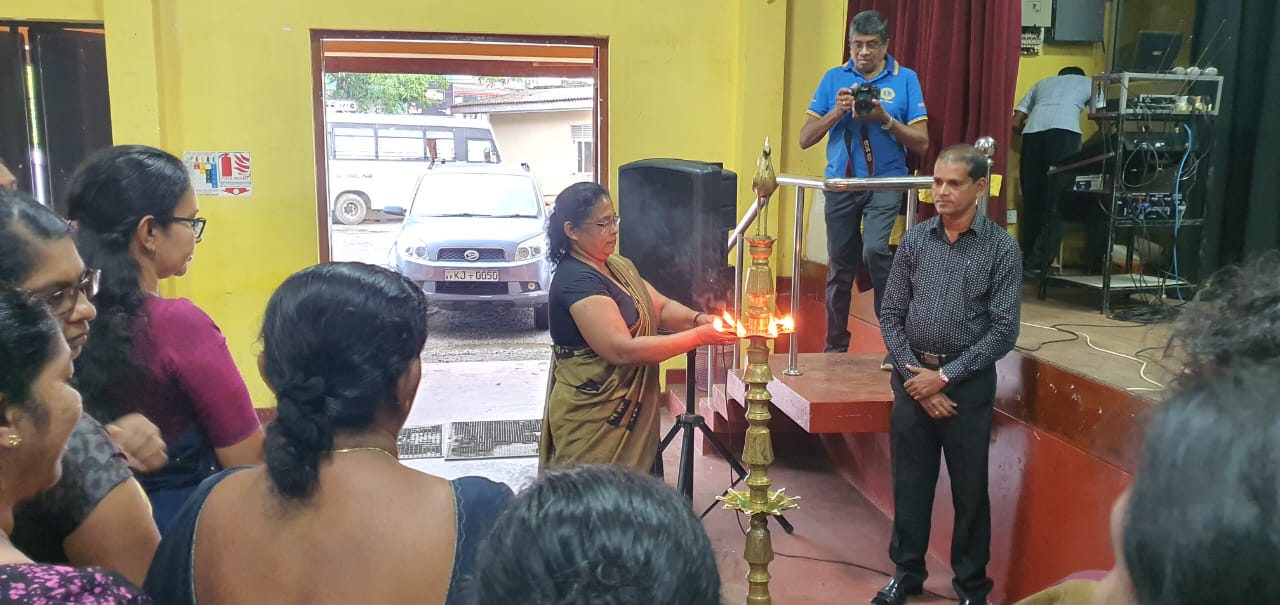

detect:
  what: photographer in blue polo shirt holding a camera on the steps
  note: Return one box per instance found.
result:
[800,10,929,370]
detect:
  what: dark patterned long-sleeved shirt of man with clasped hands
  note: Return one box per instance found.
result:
[881,215,1023,382]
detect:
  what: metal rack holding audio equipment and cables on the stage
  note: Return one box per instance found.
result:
[1041,72,1222,315]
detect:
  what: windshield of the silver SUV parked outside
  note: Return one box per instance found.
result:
[412,173,541,219]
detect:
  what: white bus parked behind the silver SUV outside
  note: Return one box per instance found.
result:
[325,111,502,225]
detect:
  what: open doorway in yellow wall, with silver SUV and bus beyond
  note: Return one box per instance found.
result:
[312,32,607,335]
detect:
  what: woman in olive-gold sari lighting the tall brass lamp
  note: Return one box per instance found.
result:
[539,183,737,471]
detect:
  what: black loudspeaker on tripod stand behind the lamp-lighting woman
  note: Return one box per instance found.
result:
[618,159,737,311]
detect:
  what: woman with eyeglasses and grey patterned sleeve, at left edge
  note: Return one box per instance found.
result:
[0,191,168,585]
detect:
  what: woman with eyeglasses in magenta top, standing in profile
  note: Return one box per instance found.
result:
[67,145,262,533]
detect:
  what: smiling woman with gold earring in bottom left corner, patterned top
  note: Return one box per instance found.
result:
[0,287,151,605]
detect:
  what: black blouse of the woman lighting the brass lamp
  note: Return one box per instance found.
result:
[548,256,640,349]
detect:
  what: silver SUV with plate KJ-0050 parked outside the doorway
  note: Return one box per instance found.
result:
[384,165,550,330]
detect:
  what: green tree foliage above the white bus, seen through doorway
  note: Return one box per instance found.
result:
[324,73,449,114]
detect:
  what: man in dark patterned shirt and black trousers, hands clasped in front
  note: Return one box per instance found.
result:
[872,145,1021,605]
